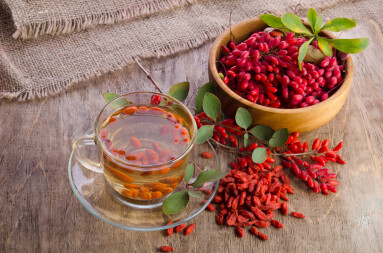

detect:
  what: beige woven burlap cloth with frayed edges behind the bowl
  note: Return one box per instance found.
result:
[0,0,383,100]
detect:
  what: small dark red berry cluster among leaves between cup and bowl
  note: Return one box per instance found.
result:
[194,112,245,147]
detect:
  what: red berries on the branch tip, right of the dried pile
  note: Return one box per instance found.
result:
[282,133,346,195]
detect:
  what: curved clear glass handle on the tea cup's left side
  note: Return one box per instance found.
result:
[73,134,103,173]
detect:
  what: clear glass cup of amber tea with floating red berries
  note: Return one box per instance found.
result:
[73,92,197,208]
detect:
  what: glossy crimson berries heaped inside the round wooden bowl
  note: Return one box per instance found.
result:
[220,31,343,108]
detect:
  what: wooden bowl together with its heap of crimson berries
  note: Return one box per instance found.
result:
[209,18,353,132]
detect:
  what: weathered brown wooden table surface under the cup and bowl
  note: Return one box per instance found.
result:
[0,20,383,252]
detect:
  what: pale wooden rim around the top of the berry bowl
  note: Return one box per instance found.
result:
[208,17,354,114]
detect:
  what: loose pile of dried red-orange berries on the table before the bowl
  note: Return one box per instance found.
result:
[212,145,304,240]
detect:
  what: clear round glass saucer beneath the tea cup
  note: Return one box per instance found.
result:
[68,142,221,231]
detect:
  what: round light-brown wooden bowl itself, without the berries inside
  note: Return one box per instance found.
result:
[209,18,354,133]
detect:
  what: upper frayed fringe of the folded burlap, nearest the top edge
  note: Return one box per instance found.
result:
[12,0,200,39]
